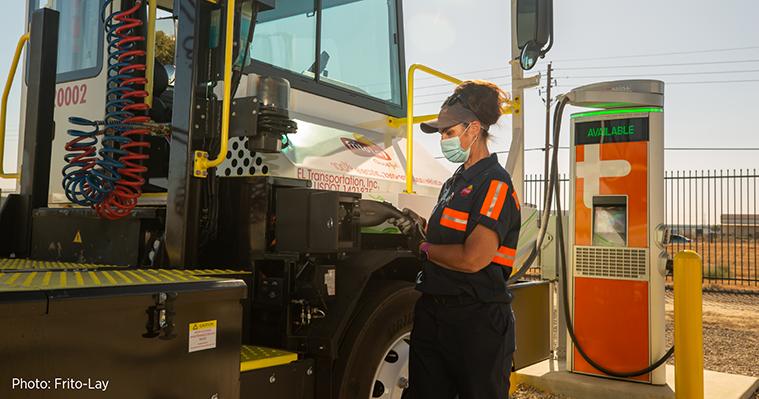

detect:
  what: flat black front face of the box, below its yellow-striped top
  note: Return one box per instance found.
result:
[0,281,245,399]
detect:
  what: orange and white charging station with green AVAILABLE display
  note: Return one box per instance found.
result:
[565,80,668,385]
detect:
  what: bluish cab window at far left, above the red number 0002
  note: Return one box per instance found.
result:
[29,0,103,83]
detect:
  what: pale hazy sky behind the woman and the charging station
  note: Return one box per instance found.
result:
[0,0,759,191]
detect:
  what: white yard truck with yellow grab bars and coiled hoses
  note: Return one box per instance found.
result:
[0,0,549,399]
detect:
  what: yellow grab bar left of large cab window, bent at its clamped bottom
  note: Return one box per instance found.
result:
[193,0,235,177]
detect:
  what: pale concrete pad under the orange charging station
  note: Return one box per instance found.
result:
[515,360,759,399]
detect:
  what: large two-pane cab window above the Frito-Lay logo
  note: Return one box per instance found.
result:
[249,0,403,106]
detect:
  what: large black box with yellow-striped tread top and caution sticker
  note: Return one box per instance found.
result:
[0,261,247,398]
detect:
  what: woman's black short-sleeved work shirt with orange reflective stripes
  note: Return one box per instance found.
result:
[416,154,521,302]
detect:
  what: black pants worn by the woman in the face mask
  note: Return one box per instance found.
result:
[409,295,516,399]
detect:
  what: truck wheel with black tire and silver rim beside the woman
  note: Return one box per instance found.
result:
[333,281,421,399]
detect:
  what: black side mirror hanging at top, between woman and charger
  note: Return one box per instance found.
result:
[516,0,553,70]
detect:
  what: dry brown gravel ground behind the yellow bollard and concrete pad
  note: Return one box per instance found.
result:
[511,287,759,399]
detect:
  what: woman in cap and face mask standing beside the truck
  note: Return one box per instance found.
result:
[391,80,521,399]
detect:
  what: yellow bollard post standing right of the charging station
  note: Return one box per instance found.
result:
[674,251,704,399]
